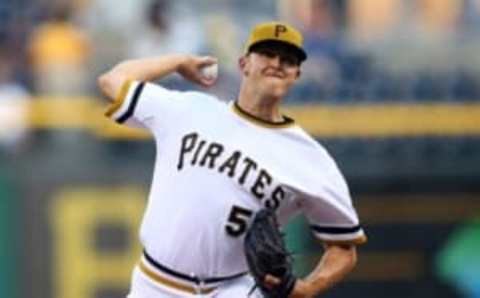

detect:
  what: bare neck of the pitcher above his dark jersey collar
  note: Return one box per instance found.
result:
[237,81,284,122]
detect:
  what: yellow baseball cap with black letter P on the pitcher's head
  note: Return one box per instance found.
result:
[245,22,307,62]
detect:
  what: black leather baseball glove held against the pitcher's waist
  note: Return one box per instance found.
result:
[244,209,296,298]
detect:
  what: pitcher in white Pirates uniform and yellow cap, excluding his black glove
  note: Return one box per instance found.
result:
[98,22,366,298]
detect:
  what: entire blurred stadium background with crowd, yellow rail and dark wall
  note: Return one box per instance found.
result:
[0,0,480,298]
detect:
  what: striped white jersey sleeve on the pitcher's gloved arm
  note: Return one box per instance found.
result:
[303,163,367,245]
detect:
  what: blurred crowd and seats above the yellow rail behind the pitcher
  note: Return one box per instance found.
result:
[0,0,480,103]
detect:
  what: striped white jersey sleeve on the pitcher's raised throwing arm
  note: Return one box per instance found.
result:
[105,81,187,133]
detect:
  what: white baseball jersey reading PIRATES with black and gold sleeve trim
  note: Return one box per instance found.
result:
[107,81,366,277]
